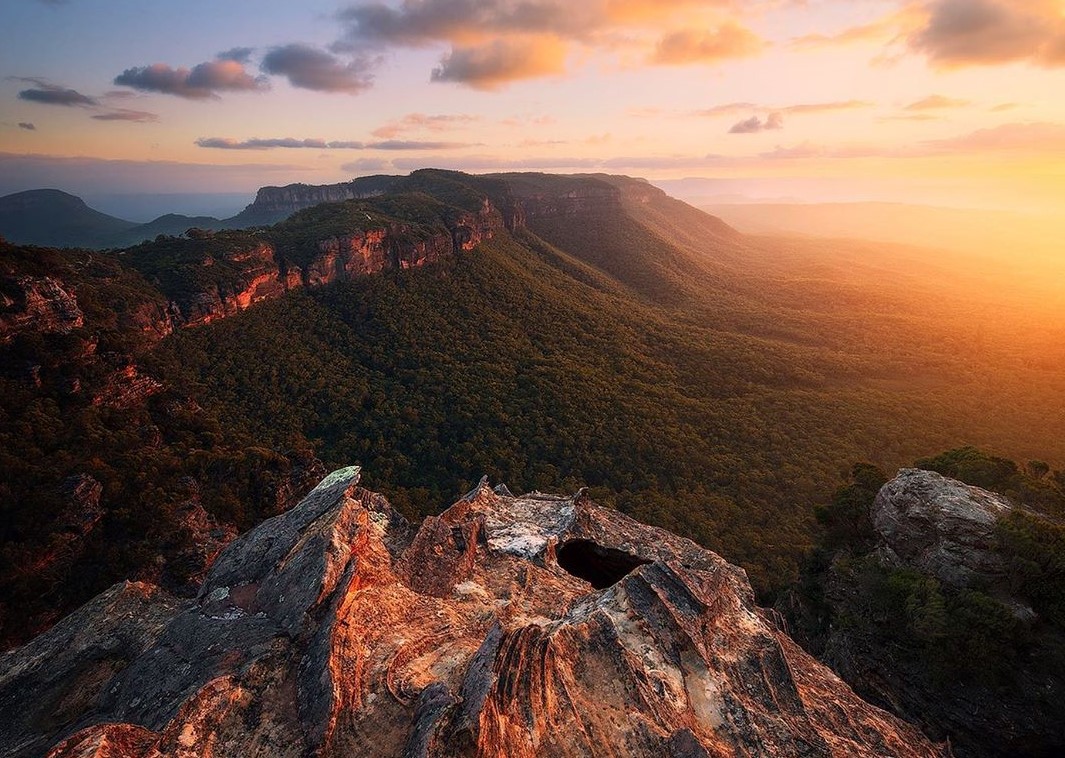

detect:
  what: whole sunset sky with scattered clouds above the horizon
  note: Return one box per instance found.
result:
[0,0,1065,213]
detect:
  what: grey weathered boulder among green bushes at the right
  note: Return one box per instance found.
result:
[871,468,1013,587]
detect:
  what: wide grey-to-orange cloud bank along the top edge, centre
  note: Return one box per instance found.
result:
[330,0,763,89]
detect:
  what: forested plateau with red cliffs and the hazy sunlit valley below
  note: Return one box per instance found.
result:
[0,169,1065,742]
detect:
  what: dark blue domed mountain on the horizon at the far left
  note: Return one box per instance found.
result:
[0,190,136,247]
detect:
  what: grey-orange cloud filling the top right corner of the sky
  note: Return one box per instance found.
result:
[907,0,1065,68]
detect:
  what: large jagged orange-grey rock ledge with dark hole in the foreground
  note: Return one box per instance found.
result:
[0,467,946,758]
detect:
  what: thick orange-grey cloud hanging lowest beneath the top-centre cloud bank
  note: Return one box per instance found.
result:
[430,37,566,89]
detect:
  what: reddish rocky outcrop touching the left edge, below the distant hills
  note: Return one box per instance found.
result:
[0,276,85,344]
